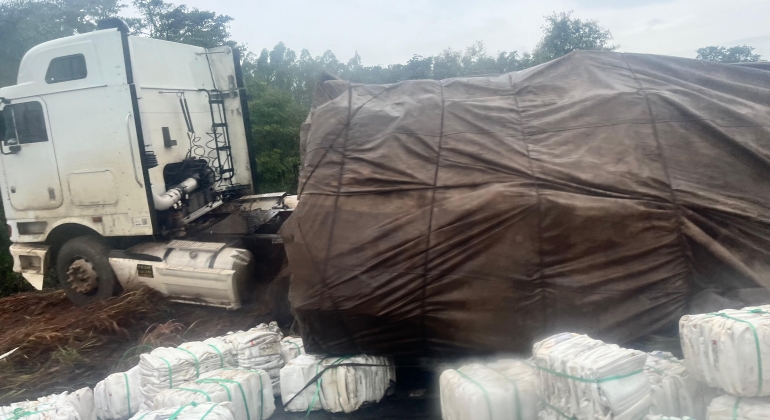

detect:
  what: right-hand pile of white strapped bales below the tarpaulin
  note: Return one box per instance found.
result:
[440,305,770,420]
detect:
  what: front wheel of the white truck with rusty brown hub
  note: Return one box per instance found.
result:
[56,235,120,306]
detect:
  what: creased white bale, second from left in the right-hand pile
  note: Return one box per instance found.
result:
[533,333,652,420]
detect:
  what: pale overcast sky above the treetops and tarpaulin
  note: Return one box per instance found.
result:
[135,0,770,66]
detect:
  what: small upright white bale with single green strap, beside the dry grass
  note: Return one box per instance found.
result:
[94,366,144,420]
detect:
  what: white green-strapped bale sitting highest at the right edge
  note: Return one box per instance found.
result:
[679,305,770,397]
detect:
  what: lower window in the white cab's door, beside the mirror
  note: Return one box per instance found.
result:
[3,102,48,145]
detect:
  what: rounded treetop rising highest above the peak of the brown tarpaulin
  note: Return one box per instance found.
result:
[532,11,618,64]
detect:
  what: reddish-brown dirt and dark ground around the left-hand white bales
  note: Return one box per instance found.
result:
[0,287,441,419]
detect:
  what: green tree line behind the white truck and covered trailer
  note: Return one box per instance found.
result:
[0,0,761,296]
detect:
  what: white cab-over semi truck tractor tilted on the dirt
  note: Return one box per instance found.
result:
[0,19,296,309]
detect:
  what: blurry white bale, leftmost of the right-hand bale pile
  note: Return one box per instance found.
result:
[439,360,540,420]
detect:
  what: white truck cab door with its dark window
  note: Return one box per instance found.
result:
[0,97,62,210]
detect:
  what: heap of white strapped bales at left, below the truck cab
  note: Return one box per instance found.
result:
[6,316,395,420]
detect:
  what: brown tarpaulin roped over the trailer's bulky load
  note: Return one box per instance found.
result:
[282,52,770,356]
